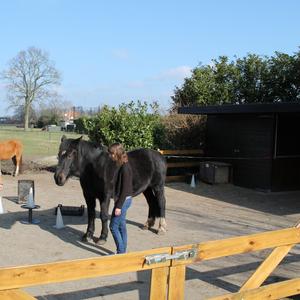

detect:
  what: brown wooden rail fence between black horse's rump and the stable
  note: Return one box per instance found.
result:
[159,149,204,182]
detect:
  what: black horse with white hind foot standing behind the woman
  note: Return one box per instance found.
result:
[54,136,167,244]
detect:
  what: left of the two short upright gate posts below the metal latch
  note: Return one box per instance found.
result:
[149,267,169,300]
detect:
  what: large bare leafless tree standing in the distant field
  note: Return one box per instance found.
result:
[1,47,61,130]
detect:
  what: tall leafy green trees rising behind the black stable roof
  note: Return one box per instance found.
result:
[172,51,300,111]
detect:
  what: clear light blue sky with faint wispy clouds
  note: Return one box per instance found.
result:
[0,0,300,116]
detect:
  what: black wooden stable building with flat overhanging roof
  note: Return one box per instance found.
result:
[178,103,300,191]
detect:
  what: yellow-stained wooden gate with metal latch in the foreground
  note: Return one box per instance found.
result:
[0,225,300,300]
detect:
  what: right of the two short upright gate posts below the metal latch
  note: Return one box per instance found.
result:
[168,265,186,300]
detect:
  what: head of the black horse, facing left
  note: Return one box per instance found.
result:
[54,136,82,186]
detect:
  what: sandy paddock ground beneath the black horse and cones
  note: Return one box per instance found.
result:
[0,161,300,300]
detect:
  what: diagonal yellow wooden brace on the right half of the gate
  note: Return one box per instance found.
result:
[240,245,294,291]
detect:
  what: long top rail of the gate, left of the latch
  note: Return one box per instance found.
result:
[0,247,171,290]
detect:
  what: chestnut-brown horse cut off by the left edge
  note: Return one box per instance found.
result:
[0,140,23,176]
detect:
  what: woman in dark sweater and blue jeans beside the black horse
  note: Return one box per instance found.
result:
[108,143,132,254]
